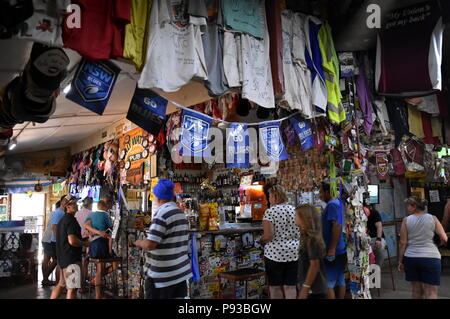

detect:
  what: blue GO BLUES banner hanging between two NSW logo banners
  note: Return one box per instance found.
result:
[225,124,250,168]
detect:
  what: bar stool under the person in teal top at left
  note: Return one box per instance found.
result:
[86,257,126,299]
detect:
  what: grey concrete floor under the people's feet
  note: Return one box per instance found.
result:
[0,266,450,299]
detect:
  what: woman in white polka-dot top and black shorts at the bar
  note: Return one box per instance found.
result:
[261,185,300,299]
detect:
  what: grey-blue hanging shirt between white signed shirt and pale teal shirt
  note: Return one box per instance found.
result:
[200,0,228,97]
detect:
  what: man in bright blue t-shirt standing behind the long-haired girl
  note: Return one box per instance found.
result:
[320,182,347,299]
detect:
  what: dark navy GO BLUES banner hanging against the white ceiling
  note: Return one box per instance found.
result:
[127,87,167,136]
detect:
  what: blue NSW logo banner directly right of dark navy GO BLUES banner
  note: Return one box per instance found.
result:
[180,110,212,157]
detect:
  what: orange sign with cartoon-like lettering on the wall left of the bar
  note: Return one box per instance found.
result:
[119,127,150,185]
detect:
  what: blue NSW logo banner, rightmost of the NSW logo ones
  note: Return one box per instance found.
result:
[259,122,289,162]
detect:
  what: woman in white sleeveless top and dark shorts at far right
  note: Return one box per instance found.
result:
[398,196,447,299]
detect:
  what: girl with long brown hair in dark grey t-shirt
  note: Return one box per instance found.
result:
[295,205,327,299]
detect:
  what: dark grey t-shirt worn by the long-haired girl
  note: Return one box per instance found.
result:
[298,237,327,295]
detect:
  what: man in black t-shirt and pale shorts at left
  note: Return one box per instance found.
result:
[50,195,89,299]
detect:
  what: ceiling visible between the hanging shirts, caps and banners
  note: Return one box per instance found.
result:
[0,0,450,153]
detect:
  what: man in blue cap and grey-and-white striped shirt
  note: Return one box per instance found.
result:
[134,179,192,299]
